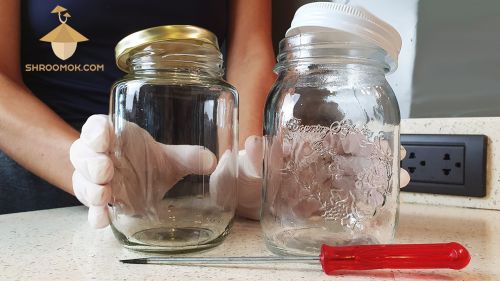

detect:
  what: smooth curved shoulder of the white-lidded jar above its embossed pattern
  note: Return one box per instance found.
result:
[266,75,400,126]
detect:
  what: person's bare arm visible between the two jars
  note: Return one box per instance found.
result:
[227,0,275,145]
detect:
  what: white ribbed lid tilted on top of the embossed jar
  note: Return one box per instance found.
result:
[286,2,401,72]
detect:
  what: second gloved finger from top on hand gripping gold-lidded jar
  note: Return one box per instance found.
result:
[69,139,114,184]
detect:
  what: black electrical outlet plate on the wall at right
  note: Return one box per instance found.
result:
[401,134,486,197]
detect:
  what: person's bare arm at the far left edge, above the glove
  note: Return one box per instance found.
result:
[0,0,78,193]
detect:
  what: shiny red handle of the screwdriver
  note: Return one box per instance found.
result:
[320,242,470,274]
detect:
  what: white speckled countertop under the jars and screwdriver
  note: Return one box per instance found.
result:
[0,204,500,281]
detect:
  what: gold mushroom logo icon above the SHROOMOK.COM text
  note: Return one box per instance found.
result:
[40,5,89,60]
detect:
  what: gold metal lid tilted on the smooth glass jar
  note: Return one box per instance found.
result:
[115,25,219,72]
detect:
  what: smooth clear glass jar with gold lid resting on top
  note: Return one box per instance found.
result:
[109,25,238,253]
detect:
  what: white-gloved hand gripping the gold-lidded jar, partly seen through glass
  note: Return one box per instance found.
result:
[70,115,217,228]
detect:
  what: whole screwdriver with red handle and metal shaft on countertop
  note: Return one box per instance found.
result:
[121,242,470,274]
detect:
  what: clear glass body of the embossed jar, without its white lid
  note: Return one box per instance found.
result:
[261,33,400,255]
